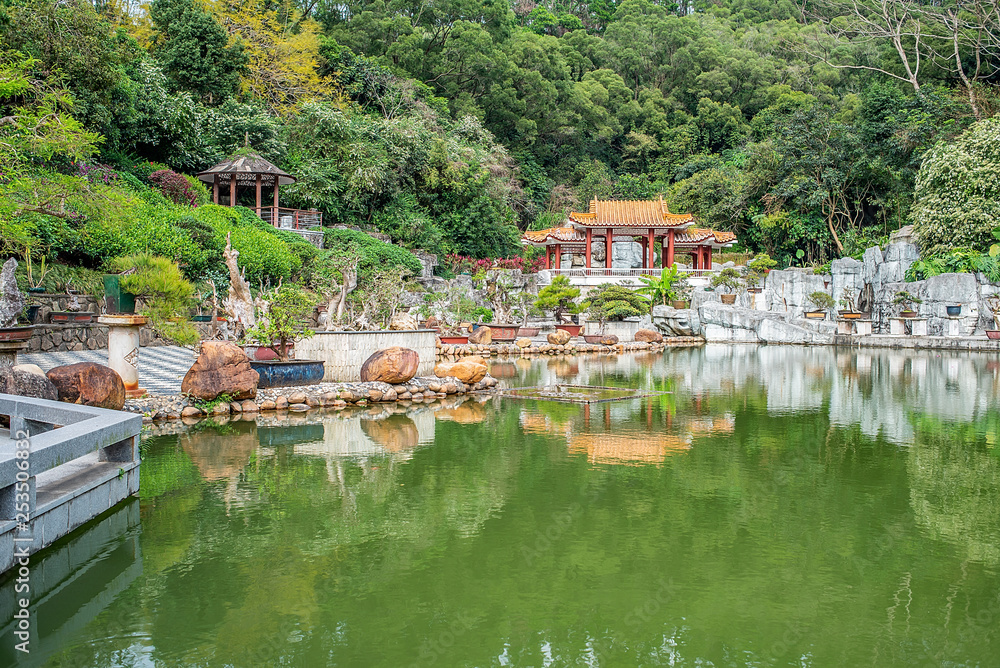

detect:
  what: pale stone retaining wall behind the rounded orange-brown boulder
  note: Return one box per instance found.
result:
[295,329,437,382]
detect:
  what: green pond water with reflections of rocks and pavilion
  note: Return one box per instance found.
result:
[0,346,1000,667]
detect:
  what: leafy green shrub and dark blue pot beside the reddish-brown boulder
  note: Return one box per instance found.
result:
[246,285,324,388]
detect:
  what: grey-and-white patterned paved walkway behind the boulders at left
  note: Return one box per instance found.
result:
[17,346,194,395]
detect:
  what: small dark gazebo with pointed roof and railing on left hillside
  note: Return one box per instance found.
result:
[198,151,323,229]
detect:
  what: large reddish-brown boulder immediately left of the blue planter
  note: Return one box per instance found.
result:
[181,341,260,401]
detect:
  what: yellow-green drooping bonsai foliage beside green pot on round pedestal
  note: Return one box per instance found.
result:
[108,253,199,345]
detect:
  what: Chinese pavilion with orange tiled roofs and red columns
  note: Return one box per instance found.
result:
[521,197,736,270]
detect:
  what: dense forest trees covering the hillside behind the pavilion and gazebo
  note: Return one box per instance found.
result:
[0,0,1000,266]
